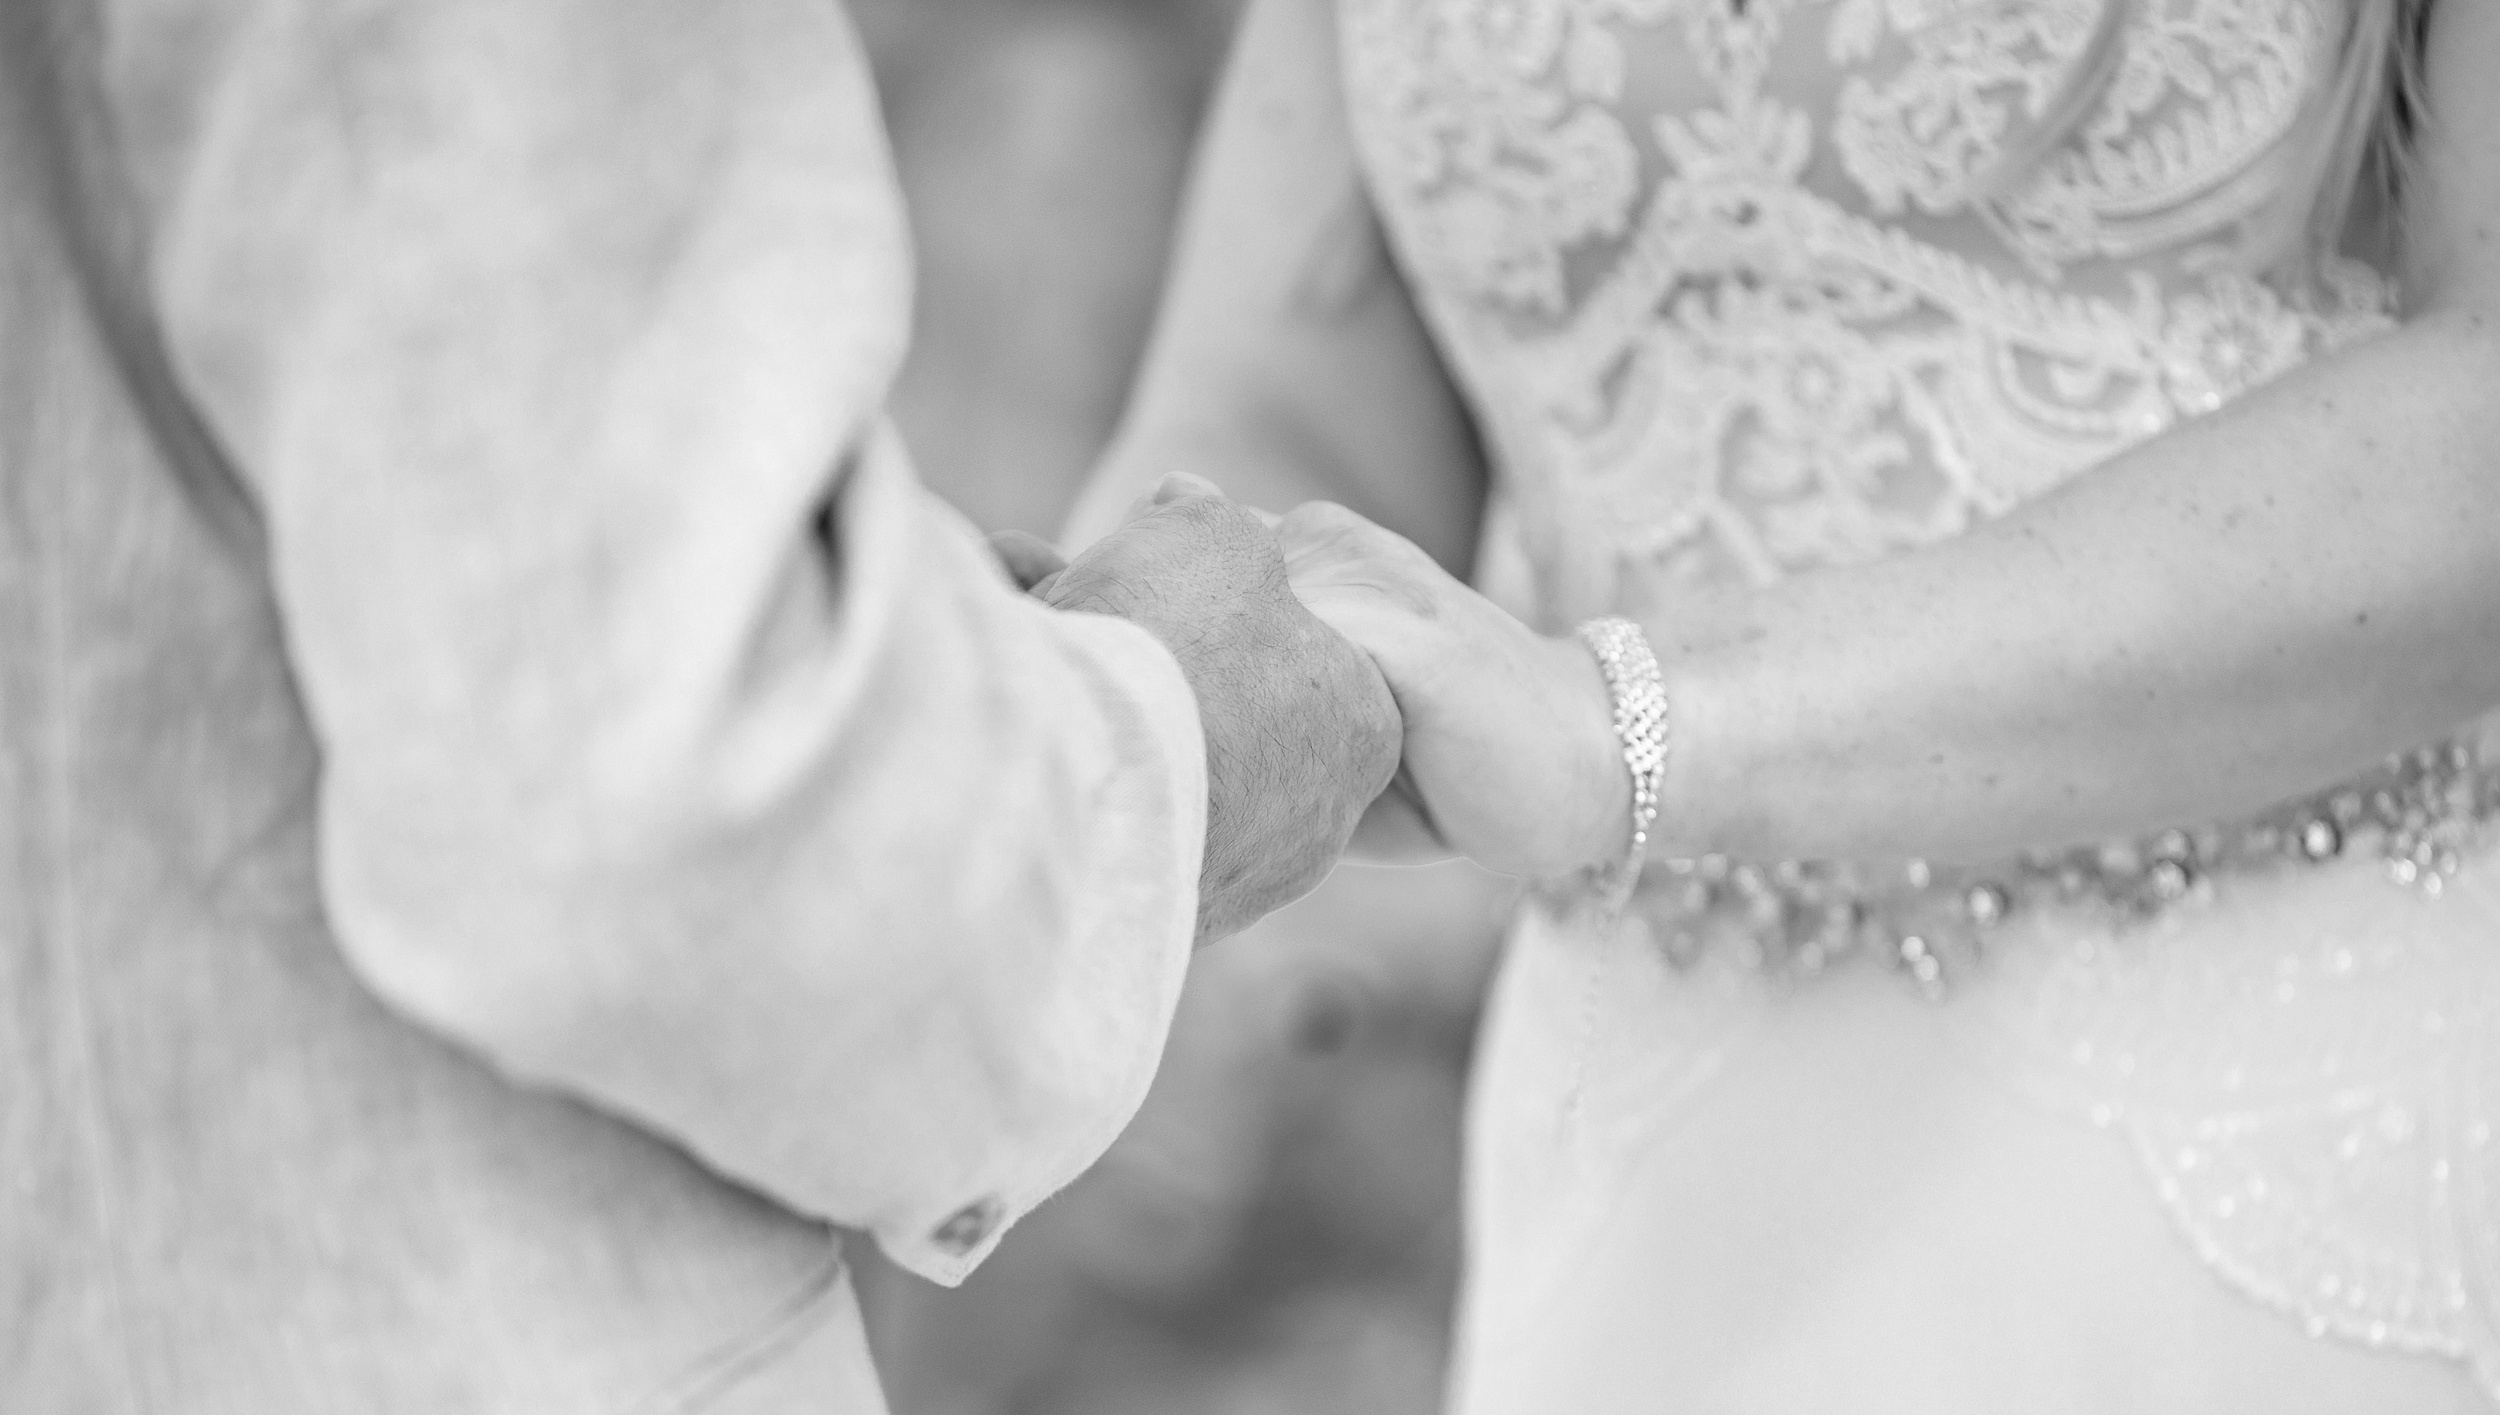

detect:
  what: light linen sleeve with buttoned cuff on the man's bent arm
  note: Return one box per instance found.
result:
[115,0,1205,1280]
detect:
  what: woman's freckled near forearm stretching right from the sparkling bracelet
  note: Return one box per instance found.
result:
[1645,313,2500,860]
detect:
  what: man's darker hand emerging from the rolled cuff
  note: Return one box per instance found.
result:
[1035,478,1403,943]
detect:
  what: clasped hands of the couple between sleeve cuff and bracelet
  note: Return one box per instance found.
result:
[993,478,1630,943]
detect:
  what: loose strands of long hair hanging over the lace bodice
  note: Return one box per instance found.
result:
[1978,0,2433,273]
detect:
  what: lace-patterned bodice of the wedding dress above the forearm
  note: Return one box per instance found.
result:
[1345,0,2388,618]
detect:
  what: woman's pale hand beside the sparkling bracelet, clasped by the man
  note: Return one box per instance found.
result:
[1278,503,1633,878]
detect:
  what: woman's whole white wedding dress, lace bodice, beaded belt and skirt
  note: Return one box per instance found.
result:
[1340,0,2500,1415]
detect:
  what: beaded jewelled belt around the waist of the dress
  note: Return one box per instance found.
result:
[1630,740,2500,998]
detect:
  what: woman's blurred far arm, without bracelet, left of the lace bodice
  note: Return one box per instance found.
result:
[1060,0,1485,562]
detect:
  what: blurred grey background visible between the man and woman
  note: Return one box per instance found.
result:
[853,0,1508,1415]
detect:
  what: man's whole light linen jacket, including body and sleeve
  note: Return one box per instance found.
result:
[0,0,1205,1415]
